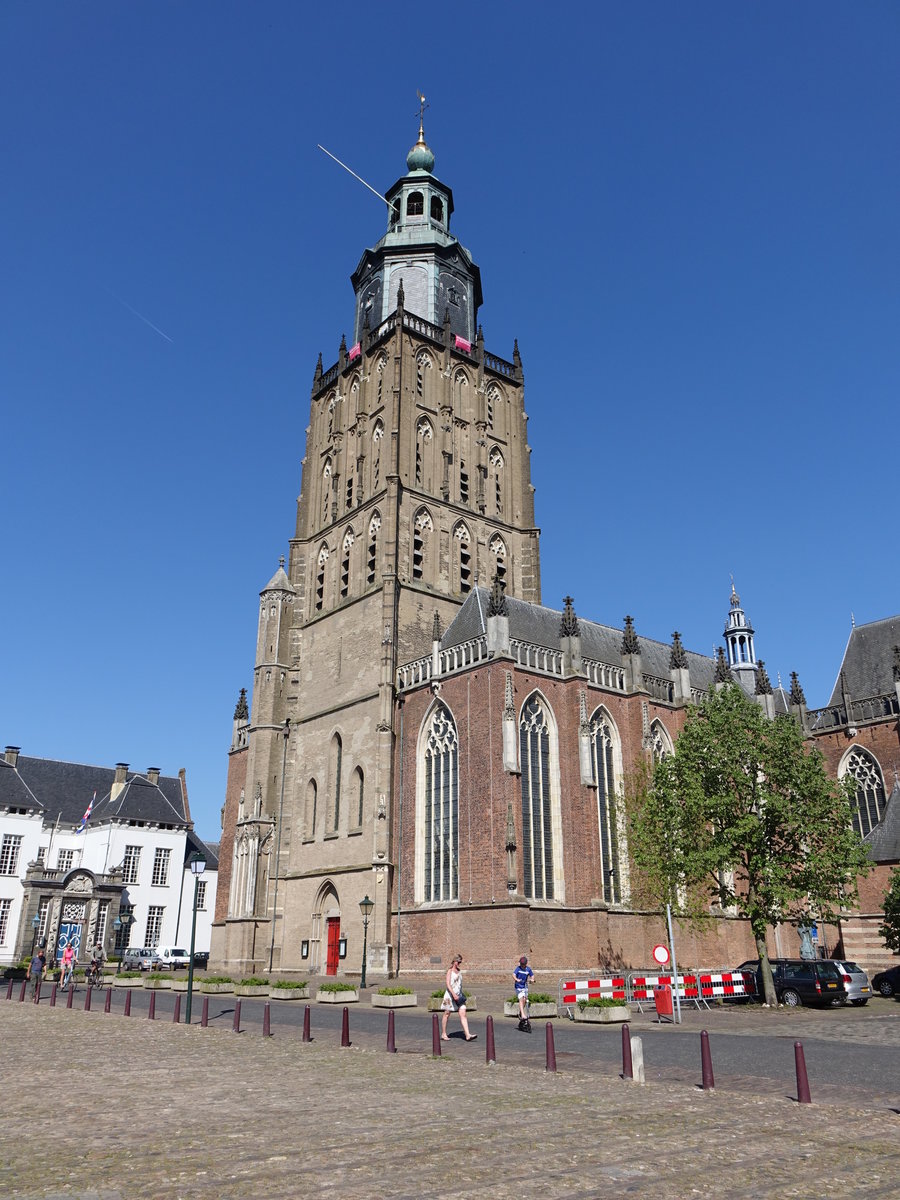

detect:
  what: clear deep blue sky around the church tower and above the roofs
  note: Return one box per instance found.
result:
[0,0,900,840]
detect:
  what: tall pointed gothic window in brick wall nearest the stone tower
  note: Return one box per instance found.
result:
[420,704,460,904]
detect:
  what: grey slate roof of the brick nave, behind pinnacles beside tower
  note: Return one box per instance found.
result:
[440,588,715,691]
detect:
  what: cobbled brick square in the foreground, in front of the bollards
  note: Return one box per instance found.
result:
[0,1003,900,1200]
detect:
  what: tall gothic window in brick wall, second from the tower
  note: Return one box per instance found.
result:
[518,696,557,900]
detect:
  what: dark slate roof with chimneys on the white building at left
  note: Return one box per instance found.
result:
[0,755,188,830]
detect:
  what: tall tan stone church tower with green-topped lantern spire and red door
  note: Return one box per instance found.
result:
[212,110,540,973]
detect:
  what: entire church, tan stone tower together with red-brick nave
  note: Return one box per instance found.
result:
[211,108,900,974]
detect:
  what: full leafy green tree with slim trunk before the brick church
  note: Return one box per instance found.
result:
[630,684,869,1004]
